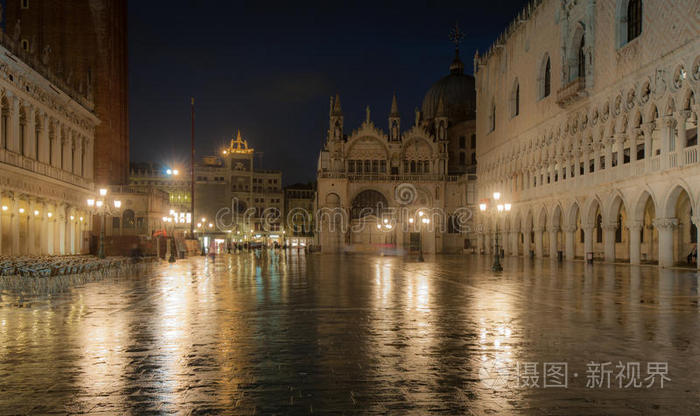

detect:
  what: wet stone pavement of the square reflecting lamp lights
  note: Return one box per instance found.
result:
[0,253,700,415]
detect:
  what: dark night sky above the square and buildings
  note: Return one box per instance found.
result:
[129,0,526,184]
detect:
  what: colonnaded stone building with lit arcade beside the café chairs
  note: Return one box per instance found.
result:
[0,43,98,256]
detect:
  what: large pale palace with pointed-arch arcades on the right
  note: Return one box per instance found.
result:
[474,0,700,266]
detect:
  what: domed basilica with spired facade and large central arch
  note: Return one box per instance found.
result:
[315,53,476,253]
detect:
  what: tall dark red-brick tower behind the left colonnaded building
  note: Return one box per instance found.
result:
[2,0,129,185]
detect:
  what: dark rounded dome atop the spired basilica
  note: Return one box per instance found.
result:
[422,55,476,123]
